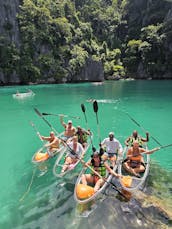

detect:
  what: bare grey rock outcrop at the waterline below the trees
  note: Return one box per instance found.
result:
[67,58,104,82]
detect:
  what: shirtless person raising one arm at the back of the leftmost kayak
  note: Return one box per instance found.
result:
[60,115,76,140]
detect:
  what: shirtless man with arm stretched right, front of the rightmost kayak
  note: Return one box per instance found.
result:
[123,141,160,177]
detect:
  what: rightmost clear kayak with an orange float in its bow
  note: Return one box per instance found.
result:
[118,147,150,192]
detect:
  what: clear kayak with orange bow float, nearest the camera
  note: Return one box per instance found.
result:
[74,157,120,204]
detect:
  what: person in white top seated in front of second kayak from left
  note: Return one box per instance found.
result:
[61,135,85,173]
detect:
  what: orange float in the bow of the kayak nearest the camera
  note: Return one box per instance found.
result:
[76,184,94,200]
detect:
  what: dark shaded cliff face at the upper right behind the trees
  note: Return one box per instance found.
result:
[126,0,172,79]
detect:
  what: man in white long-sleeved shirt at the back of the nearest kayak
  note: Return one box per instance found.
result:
[100,132,123,167]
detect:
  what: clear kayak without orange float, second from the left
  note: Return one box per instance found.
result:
[53,135,93,177]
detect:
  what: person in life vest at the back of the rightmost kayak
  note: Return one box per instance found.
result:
[125,130,149,147]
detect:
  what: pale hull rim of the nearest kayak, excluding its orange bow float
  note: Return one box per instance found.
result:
[74,157,120,204]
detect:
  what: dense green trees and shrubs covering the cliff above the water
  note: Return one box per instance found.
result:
[0,0,172,82]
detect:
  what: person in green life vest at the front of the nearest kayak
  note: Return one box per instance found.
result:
[81,151,121,192]
